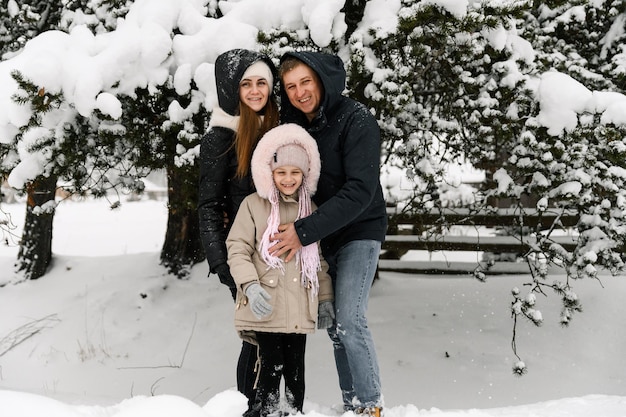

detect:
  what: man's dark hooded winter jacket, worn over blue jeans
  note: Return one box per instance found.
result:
[281,52,387,256]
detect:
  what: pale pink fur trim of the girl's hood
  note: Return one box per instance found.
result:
[250,123,321,198]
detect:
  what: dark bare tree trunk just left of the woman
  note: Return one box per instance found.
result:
[161,164,205,278]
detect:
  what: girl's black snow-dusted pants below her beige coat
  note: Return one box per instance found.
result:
[254,332,306,416]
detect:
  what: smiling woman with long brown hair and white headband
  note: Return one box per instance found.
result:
[198,49,278,405]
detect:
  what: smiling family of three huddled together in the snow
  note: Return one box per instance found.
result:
[198,49,387,417]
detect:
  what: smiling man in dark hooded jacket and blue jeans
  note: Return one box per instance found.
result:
[271,52,387,417]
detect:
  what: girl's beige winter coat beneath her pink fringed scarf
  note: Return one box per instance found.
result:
[226,193,333,338]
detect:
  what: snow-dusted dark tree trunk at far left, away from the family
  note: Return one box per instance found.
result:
[17,177,57,279]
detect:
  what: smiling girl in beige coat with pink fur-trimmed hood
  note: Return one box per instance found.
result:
[226,124,334,417]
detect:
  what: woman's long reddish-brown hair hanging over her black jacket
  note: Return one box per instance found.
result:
[235,96,279,178]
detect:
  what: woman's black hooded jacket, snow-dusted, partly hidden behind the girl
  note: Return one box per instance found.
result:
[198,49,276,272]
